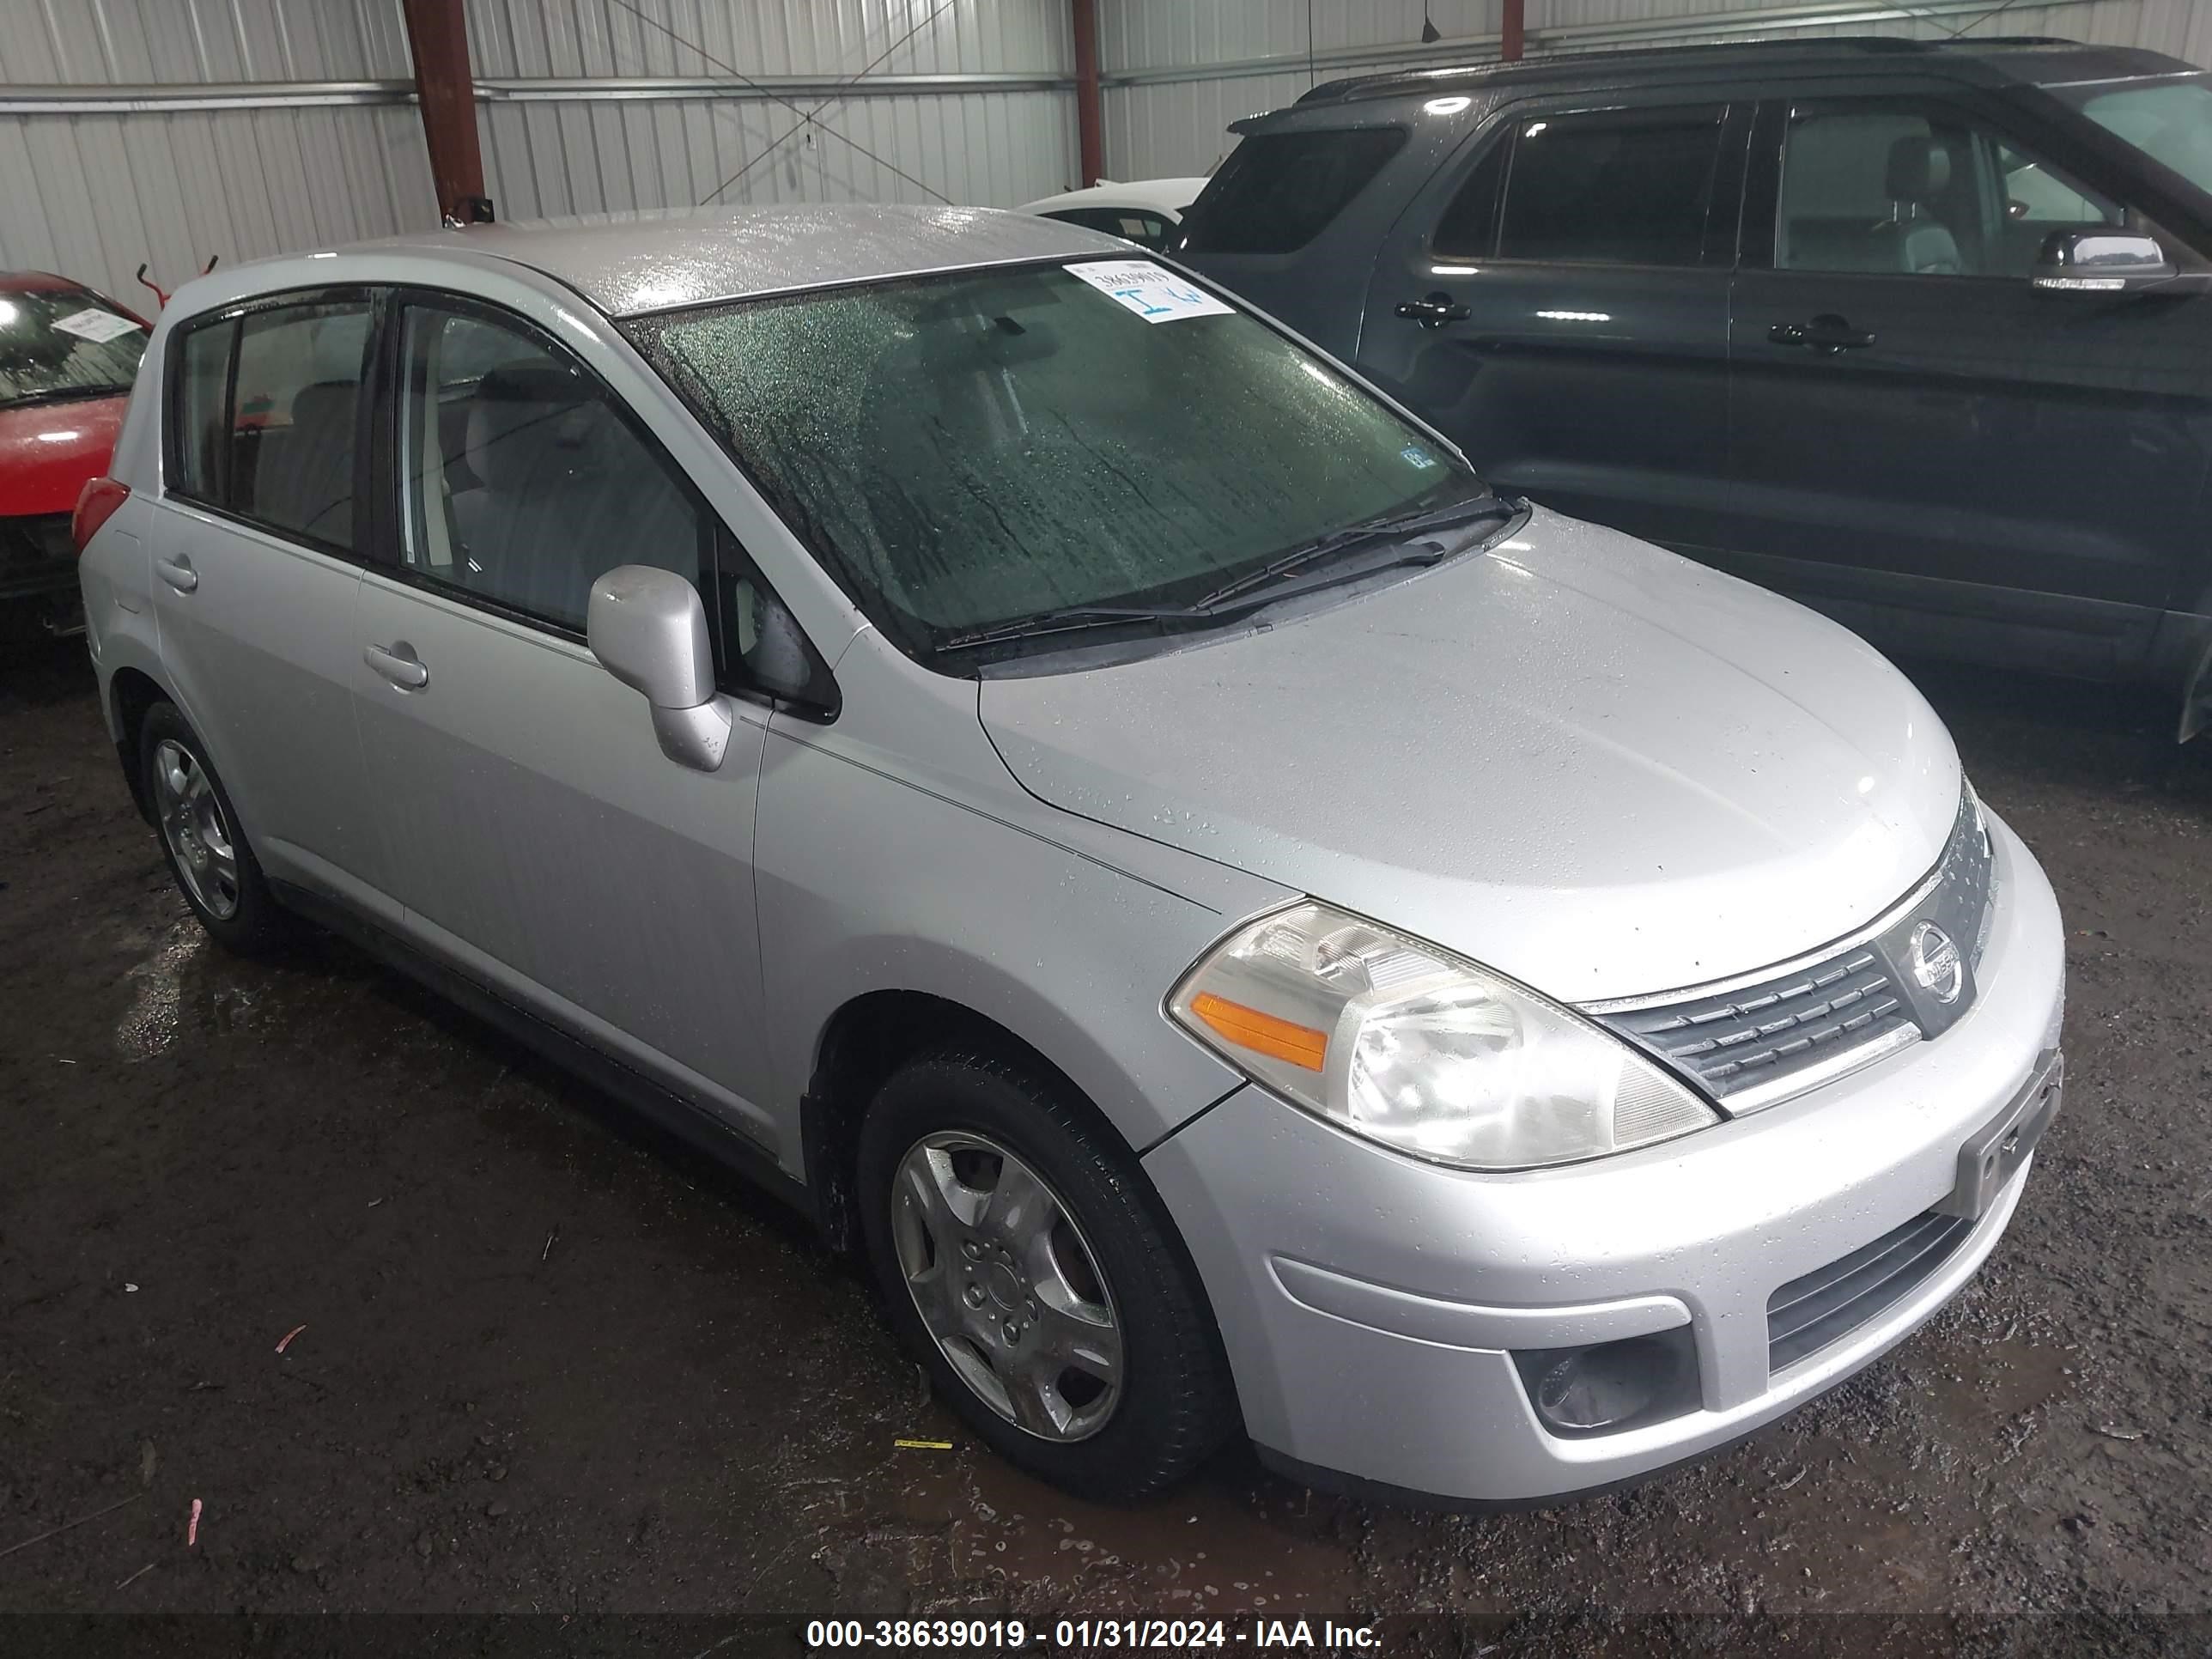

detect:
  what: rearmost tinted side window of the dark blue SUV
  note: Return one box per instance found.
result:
[1183,126,1405,254]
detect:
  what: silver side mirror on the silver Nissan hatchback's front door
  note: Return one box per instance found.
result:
[584,564,730,772]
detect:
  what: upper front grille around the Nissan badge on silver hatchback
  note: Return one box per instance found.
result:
[1590,794,1993,1110]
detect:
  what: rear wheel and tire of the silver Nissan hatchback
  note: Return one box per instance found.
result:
[139,702,289,956]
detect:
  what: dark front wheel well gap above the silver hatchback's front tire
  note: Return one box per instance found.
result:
[801,991,1113,1249]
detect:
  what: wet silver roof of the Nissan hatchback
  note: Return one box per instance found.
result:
[358,204,1128,316]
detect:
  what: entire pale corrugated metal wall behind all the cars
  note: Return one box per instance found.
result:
[0,0,2212,296]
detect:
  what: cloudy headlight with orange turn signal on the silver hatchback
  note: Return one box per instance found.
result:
[1168,900,1721,1170]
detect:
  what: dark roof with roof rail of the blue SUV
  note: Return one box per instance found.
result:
[1291,35,2192,110]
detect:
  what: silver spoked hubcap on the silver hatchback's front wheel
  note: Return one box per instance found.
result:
[891,1133,1121,1440]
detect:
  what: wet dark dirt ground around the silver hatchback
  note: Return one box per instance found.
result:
[0,628,2212,1652]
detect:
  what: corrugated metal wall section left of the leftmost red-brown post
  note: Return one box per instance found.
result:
[0,0,435,305]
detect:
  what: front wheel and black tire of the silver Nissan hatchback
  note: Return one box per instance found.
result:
[858,1048,1237,1502]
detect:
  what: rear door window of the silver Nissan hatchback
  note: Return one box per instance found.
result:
[168,296,372,553]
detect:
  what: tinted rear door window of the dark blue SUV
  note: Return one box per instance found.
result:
[1486,106,1725,265]
